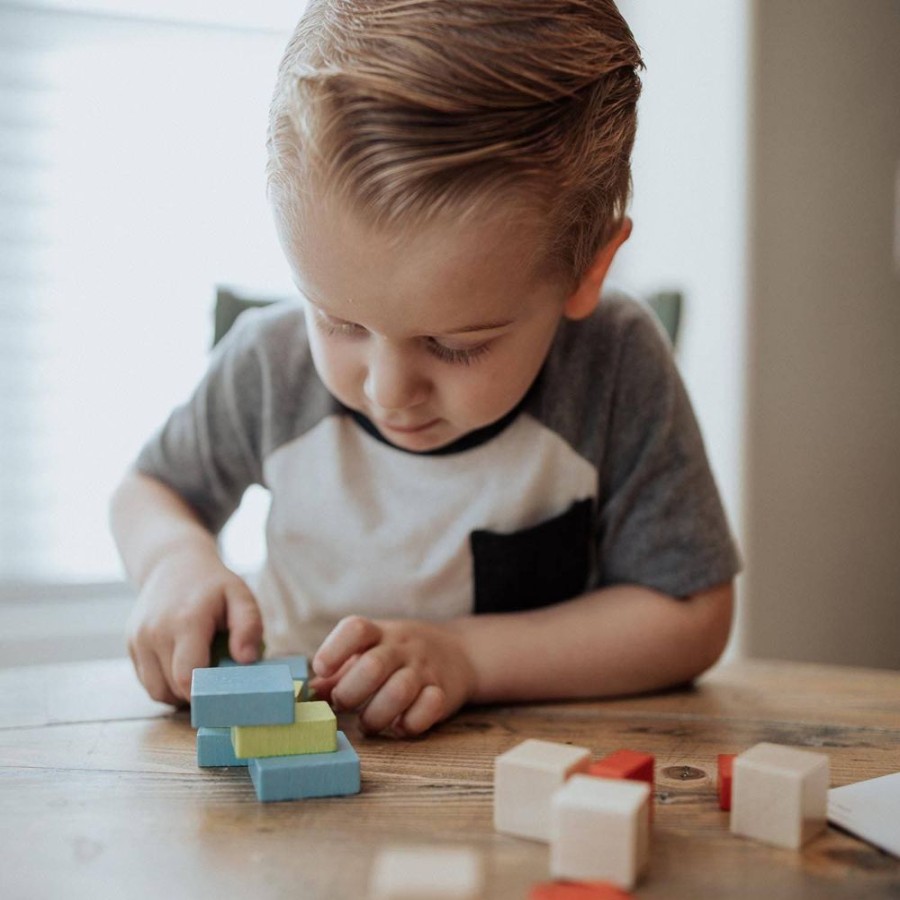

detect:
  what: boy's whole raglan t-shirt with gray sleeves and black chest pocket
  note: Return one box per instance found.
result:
[137,295,739,655]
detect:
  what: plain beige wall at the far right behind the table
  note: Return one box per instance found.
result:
[743,0,900,667]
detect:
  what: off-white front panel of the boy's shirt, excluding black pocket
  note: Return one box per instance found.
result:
[257,414,597,655]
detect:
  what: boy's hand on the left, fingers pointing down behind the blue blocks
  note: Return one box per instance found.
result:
[128,547,262,706]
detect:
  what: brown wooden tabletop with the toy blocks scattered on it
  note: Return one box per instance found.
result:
[0,661,900,900]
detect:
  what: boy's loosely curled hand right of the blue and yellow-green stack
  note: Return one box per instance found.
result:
[311,616,475,736]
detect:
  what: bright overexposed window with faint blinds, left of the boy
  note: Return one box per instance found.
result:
[0,0,300,589]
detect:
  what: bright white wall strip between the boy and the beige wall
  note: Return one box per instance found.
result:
[612,0,748,649]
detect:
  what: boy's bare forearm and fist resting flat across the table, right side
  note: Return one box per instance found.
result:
[313,582,732,734]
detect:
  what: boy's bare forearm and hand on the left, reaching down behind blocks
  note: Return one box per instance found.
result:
[110,472,262,703]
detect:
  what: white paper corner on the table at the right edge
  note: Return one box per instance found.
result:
[828,772,900,857]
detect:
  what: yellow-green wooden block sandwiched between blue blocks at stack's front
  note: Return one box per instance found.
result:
[231,700,337,759]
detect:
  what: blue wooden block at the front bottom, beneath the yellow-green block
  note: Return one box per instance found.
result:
[249,731,360,803]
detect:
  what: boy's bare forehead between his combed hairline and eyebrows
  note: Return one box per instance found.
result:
[282,192,554,333]
